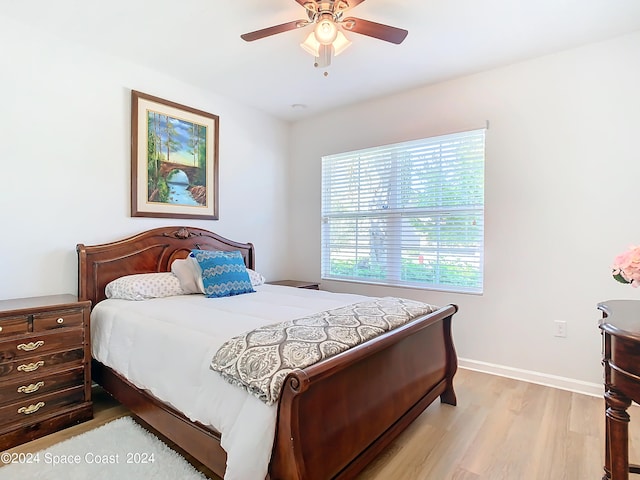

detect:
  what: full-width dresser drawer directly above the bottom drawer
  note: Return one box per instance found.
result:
[0,367,84,405]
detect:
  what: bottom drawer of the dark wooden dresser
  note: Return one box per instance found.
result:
[0,386,84,425]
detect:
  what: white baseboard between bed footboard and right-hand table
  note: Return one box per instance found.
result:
[458,358,604,397]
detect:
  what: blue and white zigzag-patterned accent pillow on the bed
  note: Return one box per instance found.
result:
[191,250,255,298]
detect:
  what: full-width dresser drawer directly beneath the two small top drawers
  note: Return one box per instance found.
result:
[0,328,84,364]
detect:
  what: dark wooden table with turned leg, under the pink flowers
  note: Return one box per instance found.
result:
[598,300,640,480]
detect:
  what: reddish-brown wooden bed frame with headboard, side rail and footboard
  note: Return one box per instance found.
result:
[77,227,457,480]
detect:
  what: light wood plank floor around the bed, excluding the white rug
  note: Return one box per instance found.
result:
[5,369,640,480]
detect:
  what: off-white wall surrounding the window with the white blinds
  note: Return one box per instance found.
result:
[290,32,640,389]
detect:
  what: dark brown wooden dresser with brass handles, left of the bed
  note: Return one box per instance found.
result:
[0,295,93,451]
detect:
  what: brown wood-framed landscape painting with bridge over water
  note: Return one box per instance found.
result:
[131,90,219,220]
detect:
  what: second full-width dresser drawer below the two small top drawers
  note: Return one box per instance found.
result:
[0,347,84,380]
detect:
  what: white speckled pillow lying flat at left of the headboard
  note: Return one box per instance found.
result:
[104,272,184,300]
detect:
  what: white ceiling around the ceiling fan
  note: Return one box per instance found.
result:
[0,0,640,120]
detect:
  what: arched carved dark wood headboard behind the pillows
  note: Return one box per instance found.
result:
[76,227,255,306]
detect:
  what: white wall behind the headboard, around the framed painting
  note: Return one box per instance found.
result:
[0,17,289,299]
